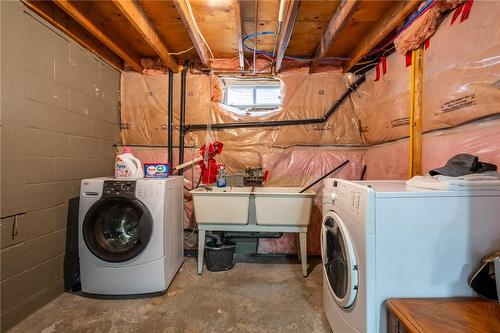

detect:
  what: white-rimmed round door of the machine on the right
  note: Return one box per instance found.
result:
[321,211,358,308]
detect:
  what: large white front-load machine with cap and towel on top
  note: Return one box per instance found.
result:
[321,179,500,333]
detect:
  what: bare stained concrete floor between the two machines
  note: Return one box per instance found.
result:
[9,258,330,333]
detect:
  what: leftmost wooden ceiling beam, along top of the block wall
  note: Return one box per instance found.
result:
[23,0,123,71]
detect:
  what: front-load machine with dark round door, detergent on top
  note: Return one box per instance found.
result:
[78,177,184,296]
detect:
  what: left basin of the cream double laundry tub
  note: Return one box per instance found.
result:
[191,186,252,224]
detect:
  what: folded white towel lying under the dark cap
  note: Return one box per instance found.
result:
[406,171,500,191]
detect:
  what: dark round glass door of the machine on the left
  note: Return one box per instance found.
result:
[82,196,153,262]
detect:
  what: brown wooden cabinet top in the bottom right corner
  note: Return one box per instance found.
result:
[386,298,500,333]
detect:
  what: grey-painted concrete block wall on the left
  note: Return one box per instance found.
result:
[0,1,120,332]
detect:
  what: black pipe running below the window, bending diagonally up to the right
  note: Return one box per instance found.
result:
[181,75,366,134]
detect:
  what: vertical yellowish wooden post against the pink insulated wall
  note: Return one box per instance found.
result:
[409,45,424,178]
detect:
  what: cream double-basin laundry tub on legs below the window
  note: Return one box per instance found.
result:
[191,187,315,276]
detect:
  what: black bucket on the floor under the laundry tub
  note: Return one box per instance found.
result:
[205,237,236,272]
